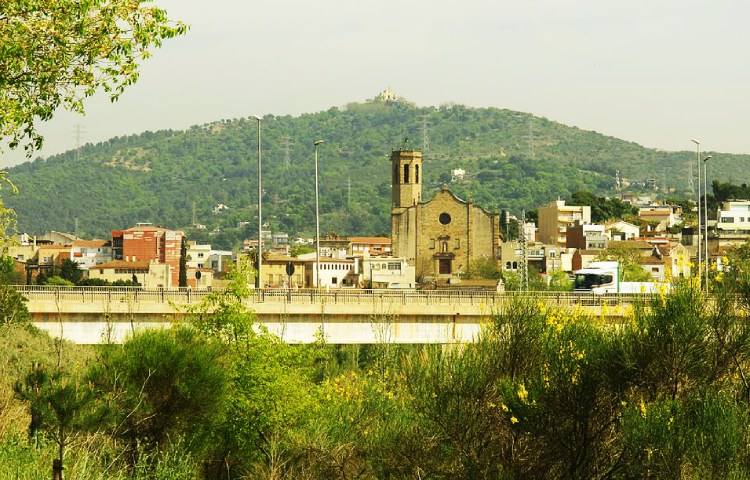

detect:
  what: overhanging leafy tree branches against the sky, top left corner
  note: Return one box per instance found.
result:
[0,0,187,156]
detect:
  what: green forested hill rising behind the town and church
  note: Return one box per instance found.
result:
[5,95,750,248]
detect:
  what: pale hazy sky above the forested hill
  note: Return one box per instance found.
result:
[0,0,750,167]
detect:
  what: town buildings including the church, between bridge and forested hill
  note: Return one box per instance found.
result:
[9,145,724,289]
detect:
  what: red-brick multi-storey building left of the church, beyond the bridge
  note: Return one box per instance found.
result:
[112,223,185,287]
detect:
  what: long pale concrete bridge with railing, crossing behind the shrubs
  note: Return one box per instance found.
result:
[17,286,634,344]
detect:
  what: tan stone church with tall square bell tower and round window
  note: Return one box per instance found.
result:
[391,150,501,281]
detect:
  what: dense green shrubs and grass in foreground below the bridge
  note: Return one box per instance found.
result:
[0,255,750,479]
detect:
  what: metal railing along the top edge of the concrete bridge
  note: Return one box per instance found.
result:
[15,285,650,307]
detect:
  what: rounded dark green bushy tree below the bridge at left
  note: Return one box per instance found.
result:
[88,327,227,458]
